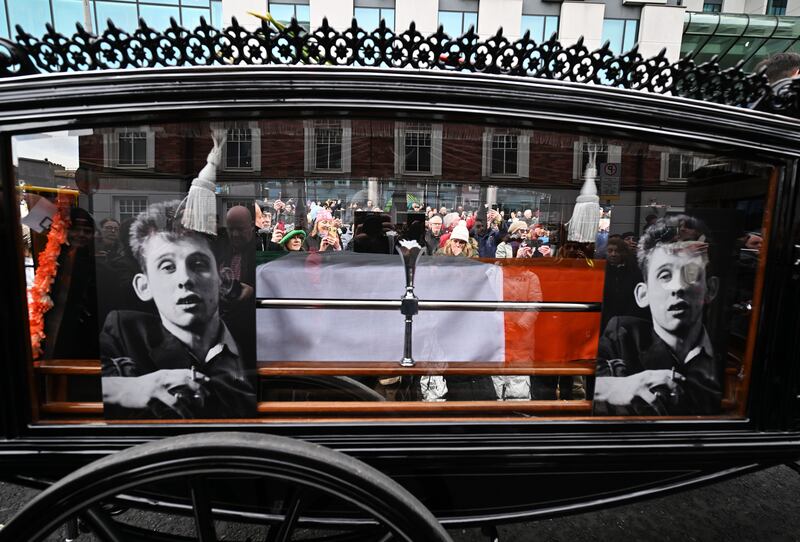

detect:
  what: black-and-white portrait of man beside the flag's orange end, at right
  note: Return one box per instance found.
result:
[594,215,723,416]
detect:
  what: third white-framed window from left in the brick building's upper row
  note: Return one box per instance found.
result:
[304,120,351,173]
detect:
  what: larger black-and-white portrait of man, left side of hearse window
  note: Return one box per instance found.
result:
[100,201,256,418]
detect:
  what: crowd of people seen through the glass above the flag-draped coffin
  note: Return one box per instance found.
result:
[254,199,559,258]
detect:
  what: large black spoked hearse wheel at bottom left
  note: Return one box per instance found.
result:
[0,432,450,542]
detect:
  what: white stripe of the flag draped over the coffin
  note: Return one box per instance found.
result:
[256,252,505,362]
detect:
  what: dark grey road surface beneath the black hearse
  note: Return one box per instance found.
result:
[0,466,800,542]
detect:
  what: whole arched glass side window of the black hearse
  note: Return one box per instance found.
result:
[13,123,778,423]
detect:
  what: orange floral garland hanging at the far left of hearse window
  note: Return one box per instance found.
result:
[28,194,72,359]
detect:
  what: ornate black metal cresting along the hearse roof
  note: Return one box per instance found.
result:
[0,18,800,116]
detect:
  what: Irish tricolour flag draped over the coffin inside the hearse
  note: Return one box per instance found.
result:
[256,252,604,367]
